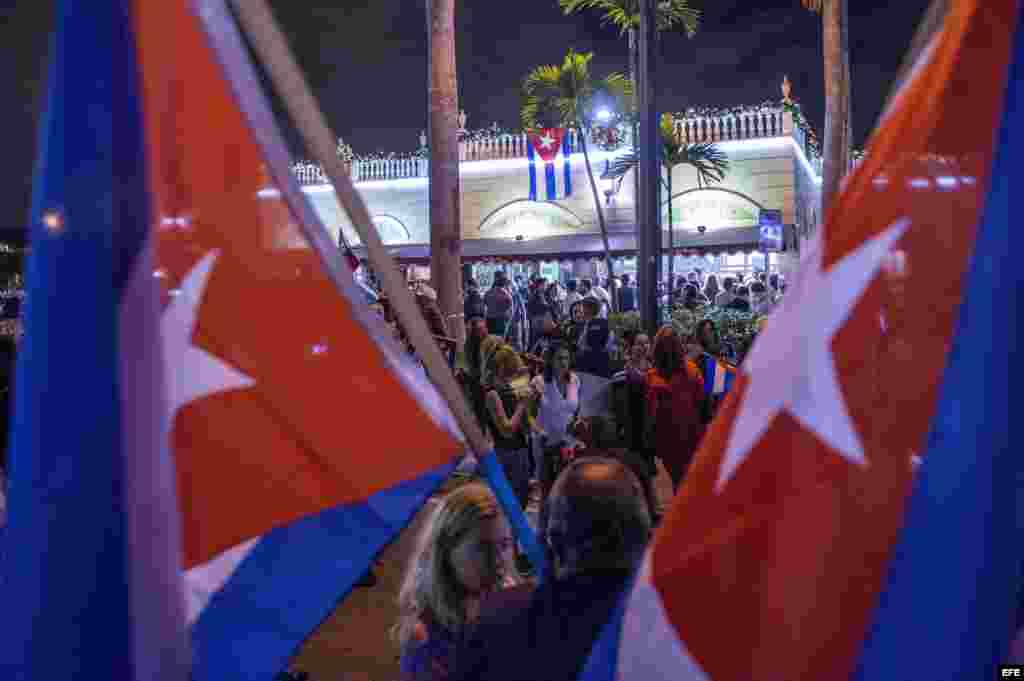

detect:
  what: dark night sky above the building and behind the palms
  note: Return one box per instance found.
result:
[0,0,929,228]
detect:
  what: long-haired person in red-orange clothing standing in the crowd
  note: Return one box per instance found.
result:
[646,326,707,492]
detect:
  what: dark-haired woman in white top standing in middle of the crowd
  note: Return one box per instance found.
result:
[532,344,580,499]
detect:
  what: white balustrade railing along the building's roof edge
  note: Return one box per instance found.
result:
[294,108,821,185]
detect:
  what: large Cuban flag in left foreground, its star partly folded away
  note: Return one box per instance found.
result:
[0,0,464,681]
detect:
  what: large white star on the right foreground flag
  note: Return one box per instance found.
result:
[717,219,909,492]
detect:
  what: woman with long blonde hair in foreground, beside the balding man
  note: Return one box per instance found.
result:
[391,482,516,681]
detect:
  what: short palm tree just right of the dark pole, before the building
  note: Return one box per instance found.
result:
[608,114,729,292]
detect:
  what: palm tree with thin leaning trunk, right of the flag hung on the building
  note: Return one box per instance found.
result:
[520,49,633,276]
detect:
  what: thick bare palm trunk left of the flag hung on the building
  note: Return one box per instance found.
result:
[426,0,462,335]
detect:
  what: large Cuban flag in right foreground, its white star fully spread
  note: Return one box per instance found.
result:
[584,0,1024,681]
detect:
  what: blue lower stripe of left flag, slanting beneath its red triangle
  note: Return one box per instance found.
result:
[193,462,455,681]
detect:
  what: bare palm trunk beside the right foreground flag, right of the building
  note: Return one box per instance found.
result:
[821,0,851,214]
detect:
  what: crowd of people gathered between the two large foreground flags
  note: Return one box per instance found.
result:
[393,272,757,681]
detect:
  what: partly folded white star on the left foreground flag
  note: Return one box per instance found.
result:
[160,251,256,424]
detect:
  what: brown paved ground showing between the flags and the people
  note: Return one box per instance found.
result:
[293,458,672,681]
